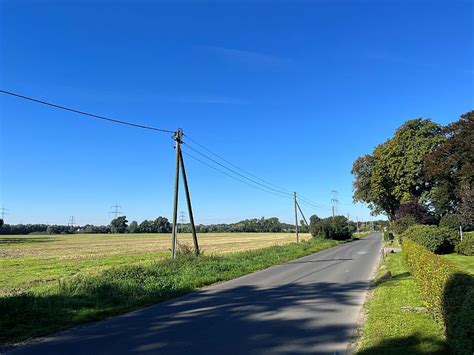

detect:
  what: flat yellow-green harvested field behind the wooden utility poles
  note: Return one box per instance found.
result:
[0,233,310,296]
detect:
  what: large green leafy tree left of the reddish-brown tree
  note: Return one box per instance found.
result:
[352,118,444,220]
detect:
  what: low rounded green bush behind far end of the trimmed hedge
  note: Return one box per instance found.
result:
[401,224,459,254]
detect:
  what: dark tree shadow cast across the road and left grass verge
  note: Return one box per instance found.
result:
[0,281,368,354]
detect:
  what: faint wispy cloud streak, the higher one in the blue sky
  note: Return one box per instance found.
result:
[196,46,291,67]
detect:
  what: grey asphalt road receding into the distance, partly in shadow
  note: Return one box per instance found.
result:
[12,234,382,355]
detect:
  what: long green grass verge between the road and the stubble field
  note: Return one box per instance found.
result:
[0,239,338,344]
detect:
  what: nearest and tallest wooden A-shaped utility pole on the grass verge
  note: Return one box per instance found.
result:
[171,129,199,259]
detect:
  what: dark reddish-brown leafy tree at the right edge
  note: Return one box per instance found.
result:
[426,111,474,215]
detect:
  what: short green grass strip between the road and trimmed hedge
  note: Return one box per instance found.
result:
[357,253,447,355]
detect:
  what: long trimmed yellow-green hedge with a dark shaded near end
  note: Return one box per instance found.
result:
[402,239,474,355]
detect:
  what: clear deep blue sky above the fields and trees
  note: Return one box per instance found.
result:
[0,0,474,224]
